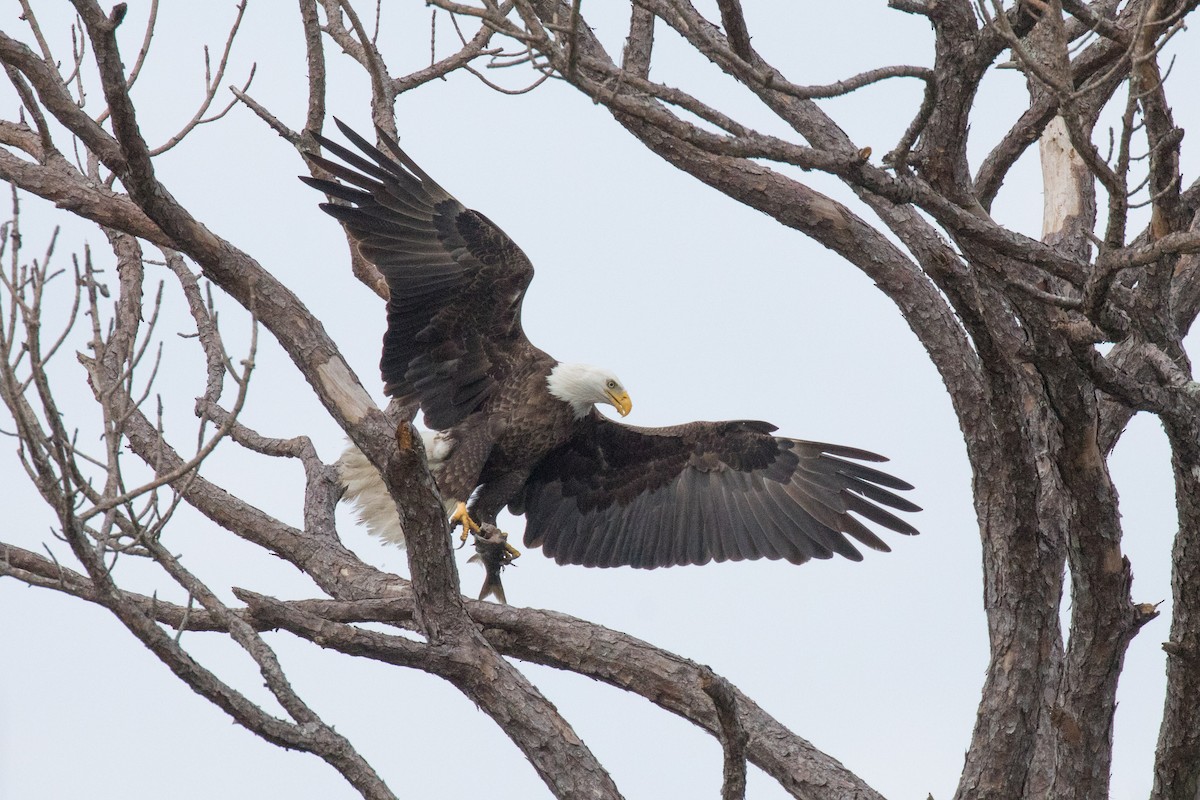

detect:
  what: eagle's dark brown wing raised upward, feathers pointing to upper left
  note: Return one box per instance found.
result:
[301,121,533,429]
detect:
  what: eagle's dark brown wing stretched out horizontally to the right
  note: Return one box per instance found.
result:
[514,413,920,569]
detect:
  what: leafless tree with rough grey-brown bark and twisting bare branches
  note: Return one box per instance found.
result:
[0,0,1200,800]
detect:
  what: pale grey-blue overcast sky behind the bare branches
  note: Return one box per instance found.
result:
[0,0,1196,800]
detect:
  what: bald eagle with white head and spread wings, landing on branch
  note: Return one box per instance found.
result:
[302,121,919,569]
